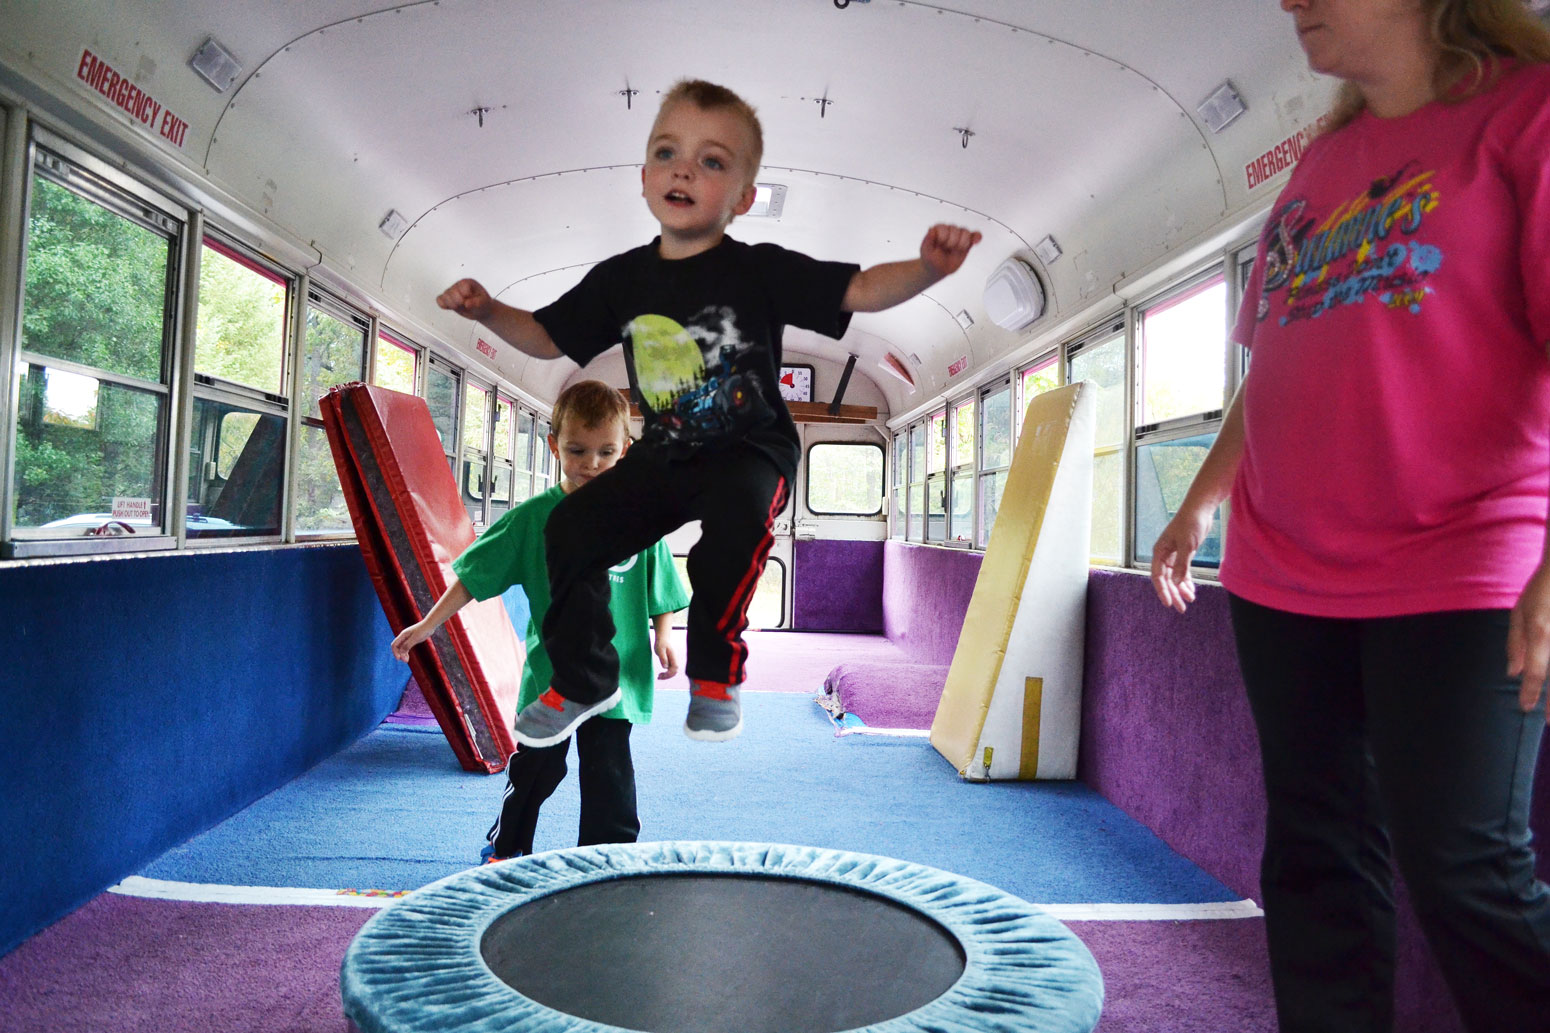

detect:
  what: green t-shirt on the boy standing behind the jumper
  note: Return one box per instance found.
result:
[453,484,688,724]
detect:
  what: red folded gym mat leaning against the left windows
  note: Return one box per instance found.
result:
[321,383,522,774]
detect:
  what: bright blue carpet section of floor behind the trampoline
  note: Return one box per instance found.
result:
[141,690,1237,904]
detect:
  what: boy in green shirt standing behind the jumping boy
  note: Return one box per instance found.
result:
[392,380,688,861]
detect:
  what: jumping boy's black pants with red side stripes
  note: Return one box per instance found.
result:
[543,444,786,703]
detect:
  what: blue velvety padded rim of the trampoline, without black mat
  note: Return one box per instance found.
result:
[339,842,1104,1033]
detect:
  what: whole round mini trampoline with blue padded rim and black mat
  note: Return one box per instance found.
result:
[339,842,1104,1033]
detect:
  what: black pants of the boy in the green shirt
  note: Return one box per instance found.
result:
[485,717,640,858]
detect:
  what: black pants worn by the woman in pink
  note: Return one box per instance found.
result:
[1231,597,1550,1033]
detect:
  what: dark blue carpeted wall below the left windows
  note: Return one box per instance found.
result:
[0,544,406,954]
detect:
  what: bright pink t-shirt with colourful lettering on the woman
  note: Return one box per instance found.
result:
[1221,65,1550,617]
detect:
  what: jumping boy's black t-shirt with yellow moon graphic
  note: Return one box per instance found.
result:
[533,237,860,481]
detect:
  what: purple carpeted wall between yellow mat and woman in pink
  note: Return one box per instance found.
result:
[1077,571,1550,1033]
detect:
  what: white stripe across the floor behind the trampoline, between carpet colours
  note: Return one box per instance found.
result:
[107,875,1265,921]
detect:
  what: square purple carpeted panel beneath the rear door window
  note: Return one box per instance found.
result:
[791,540,884,634]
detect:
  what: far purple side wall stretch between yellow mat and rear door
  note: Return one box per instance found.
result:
[882,541,983,664]
